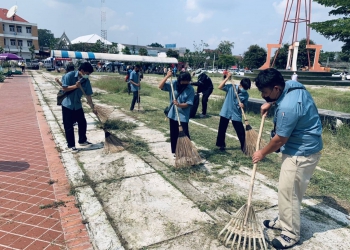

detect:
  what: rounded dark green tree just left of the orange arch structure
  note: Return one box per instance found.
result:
[242,44,267,69]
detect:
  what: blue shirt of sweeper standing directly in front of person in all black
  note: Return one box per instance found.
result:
[162,80,194,122]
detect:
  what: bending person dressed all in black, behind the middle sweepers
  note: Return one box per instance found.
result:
[191,70,214,118]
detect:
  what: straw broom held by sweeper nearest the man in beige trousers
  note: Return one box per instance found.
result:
[233,86,266,156]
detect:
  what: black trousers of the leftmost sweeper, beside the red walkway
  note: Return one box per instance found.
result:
[62,106,87,148]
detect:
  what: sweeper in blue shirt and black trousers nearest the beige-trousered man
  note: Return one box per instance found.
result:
[216,72,251,151]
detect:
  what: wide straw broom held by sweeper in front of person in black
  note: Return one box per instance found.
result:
[170,78,202,168]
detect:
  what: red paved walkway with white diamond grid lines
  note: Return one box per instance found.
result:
[0,75,92,250]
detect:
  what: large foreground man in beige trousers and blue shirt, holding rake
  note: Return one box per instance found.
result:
[252,68,323,249]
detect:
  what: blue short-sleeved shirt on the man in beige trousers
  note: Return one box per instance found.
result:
[274,80,323,156]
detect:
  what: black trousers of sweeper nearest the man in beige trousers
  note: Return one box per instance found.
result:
[216,116,245,151]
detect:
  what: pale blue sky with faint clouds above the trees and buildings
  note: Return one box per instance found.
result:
[0,0,343,55]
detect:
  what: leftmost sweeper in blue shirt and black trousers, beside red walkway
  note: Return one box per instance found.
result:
[62,62,97,153]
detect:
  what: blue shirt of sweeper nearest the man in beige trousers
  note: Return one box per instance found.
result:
[220,83,249,122]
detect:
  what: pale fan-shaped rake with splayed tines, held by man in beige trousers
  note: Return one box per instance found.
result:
[218,115,267,250]
